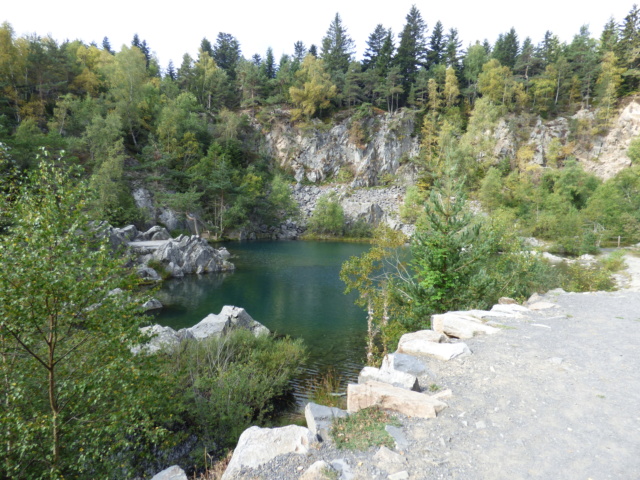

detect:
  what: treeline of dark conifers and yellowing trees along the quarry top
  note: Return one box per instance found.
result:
[0,5,640,233]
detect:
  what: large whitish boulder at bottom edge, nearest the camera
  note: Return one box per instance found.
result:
[222,425,317,480]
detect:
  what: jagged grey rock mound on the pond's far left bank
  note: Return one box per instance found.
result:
[152,235,234,277]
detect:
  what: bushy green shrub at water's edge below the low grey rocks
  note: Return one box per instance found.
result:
[162,329,305,458]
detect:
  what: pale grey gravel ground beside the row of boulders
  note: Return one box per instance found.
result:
[232,253,640,480]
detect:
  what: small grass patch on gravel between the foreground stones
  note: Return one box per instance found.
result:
[331,407,400,451]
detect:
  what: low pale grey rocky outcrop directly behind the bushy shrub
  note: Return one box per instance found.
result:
[132,305,270,353]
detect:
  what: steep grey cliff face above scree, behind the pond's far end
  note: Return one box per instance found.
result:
[265,111,419,187]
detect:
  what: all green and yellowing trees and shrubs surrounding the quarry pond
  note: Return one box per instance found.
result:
[0,5,640,478]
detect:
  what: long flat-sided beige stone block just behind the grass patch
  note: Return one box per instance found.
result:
[347,381,447,418]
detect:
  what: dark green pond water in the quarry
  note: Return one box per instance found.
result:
[157,241,369,395]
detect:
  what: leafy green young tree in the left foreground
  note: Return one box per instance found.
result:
[0,154,161,478]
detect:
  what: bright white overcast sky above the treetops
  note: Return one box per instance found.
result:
[0,0,633,67]
